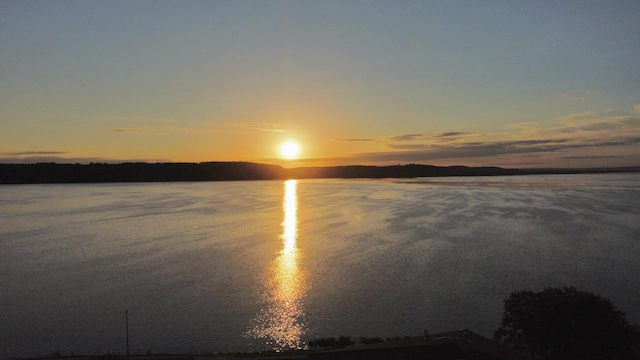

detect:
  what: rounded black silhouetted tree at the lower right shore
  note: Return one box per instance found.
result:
[494,287,640,359]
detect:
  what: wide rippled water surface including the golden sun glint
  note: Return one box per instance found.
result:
[0,174,640,357]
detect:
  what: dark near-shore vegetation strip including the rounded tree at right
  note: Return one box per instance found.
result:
[22,287,640,360]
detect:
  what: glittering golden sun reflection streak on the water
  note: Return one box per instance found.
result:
[249,180,306,351]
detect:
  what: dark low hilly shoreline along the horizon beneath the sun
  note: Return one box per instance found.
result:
[0,162,640,184]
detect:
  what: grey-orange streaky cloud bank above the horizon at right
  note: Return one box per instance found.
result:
[322,112,640,166]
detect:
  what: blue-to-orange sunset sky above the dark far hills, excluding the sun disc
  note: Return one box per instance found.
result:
[0,0,640,167]
